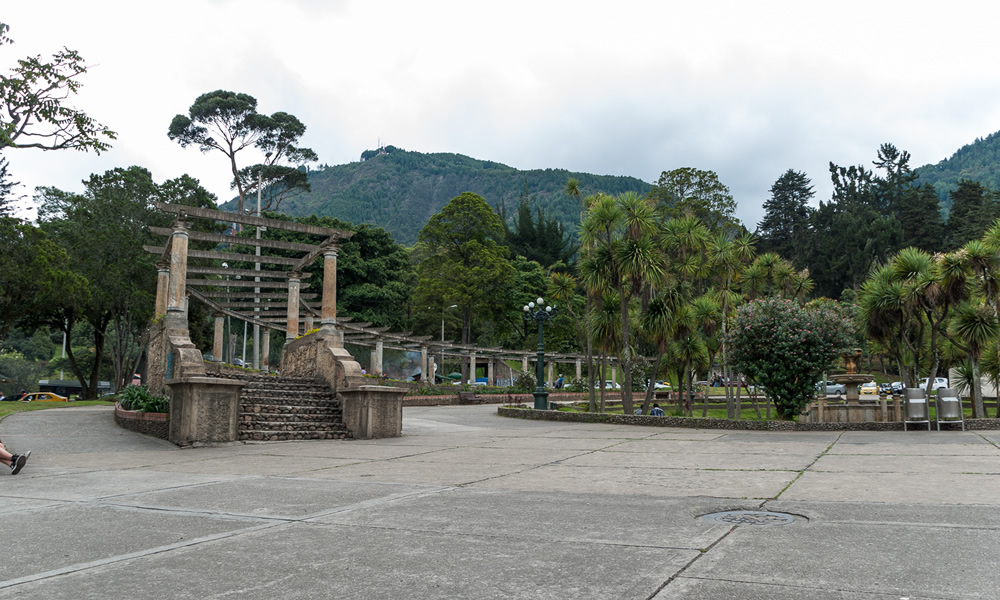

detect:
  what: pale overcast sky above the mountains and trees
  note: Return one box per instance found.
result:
[0,0,1000,229]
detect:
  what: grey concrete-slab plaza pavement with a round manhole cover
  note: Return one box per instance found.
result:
[0,406,1000,600]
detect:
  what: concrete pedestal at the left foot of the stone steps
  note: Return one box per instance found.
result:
[166,377,245,446]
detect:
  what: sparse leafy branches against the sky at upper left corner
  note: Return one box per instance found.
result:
[0,23,116,154]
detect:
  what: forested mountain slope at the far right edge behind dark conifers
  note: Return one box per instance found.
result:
[913,131,1000,216]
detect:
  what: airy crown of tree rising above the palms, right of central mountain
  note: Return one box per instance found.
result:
[648,167,736,230]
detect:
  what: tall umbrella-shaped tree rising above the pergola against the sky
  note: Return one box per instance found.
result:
[167,90,318,213]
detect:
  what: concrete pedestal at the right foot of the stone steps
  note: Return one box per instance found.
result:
[337,385,406,440]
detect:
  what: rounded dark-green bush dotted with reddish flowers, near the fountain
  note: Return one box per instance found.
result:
[728,299,852,419]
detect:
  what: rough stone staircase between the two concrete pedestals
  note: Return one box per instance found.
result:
[239,373,351,441]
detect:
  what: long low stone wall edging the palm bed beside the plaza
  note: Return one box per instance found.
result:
[497,406,1000,431]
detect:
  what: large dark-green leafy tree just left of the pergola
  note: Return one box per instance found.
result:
[30,166,209,398]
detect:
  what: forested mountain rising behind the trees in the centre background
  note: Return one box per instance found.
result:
[240,146,652,245]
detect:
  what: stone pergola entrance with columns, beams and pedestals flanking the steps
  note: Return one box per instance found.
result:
[146,203,405,444]
